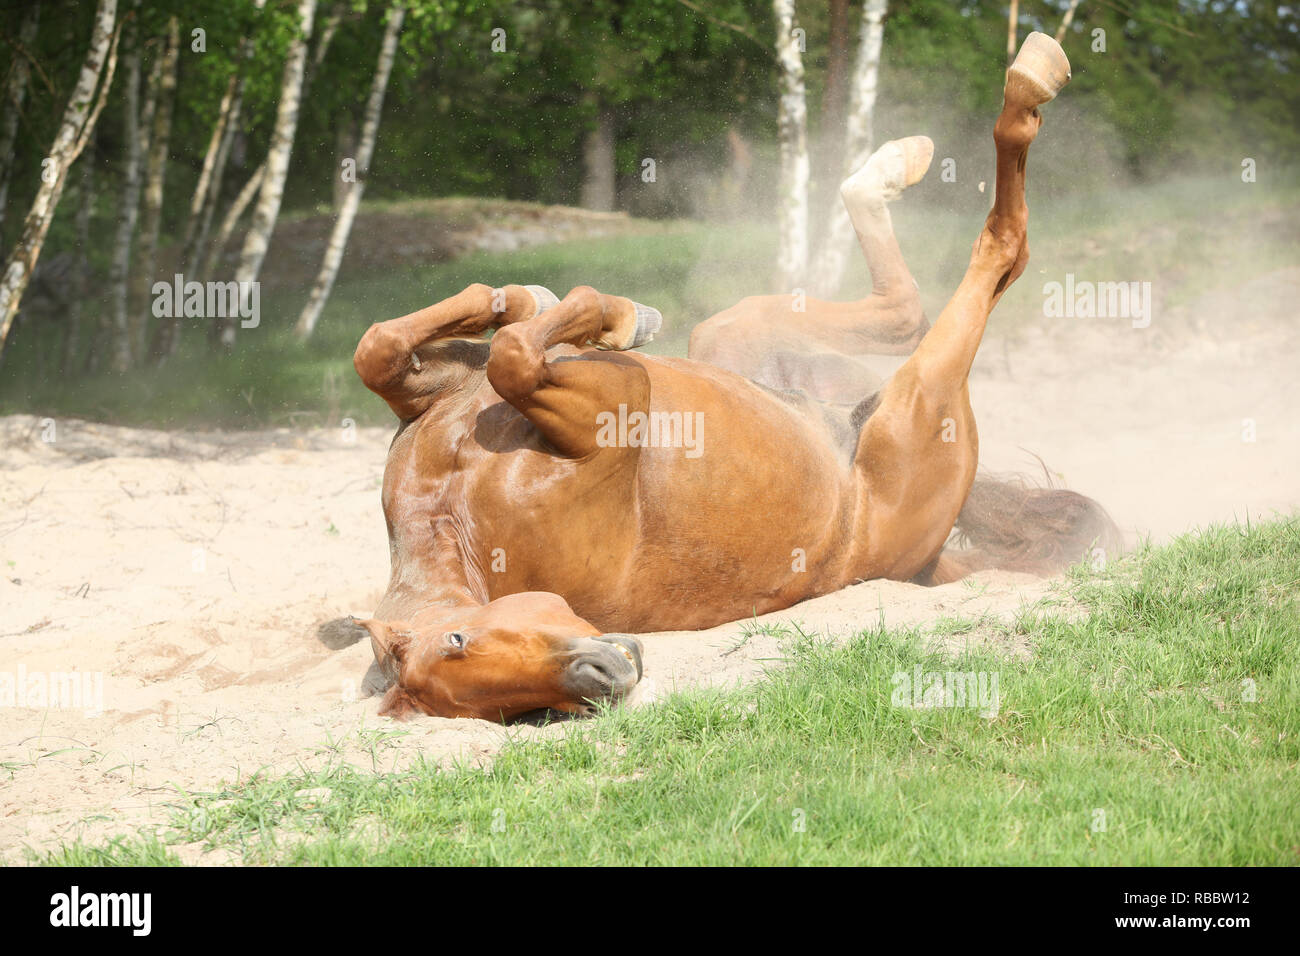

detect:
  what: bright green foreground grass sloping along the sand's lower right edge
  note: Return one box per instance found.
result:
[43,518,1300,865]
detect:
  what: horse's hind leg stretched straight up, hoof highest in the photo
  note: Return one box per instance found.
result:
[854,33,1070,579]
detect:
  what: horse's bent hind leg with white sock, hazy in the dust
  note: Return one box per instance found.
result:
[689,137,935,403]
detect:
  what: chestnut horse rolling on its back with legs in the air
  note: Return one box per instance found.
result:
[355,34,1106,721]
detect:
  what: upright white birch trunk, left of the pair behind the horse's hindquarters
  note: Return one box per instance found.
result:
[772,0,810,291]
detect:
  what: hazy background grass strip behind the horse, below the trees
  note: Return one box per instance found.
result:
[0,173,1300,427]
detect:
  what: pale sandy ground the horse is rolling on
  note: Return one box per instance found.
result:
[0,269,1300,862]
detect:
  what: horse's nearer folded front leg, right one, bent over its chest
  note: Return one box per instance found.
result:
[488,286,659,458]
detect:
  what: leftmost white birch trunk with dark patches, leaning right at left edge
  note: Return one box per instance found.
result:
[0,0,117,349]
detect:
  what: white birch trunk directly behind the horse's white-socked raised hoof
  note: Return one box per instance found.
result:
[813,0,887,297]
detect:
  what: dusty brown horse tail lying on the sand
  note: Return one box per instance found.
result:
[931,473,1123,584]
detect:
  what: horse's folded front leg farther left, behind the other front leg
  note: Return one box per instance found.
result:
[352,282,558,421]
